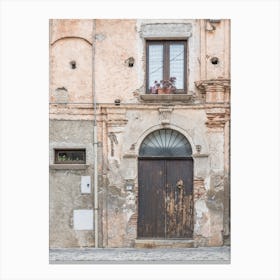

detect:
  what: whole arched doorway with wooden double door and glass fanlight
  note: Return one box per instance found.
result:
[137,129,193,239]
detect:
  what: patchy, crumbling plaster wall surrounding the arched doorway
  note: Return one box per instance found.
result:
[100,106,228,247]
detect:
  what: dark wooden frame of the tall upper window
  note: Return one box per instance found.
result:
[146,39,188,94]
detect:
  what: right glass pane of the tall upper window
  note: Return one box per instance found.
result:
[170,44,184,89]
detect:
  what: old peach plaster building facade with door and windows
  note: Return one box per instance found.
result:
[49,19,230,248]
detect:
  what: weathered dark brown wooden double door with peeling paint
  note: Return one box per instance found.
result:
[137,158,193,239]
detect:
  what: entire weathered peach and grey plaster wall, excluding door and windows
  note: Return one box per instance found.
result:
[50,19,230,247]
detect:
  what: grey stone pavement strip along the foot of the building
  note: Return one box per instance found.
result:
[49,246,230,264]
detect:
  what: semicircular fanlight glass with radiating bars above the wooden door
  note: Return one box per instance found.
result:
[139,129,192,157]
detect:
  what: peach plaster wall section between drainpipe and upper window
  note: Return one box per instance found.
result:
[95,20,139,103]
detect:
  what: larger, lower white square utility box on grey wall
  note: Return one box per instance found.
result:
[73,209,93,230]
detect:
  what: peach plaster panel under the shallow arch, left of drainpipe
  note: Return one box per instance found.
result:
[50,38,92,103]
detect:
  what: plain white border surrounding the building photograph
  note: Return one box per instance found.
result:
[0,0,280,280]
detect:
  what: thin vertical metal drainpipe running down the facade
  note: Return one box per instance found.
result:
[92,20,98,248]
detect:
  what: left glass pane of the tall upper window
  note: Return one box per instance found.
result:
[149,45,163,88]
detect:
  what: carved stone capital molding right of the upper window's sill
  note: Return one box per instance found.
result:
[195,78,230,103]
